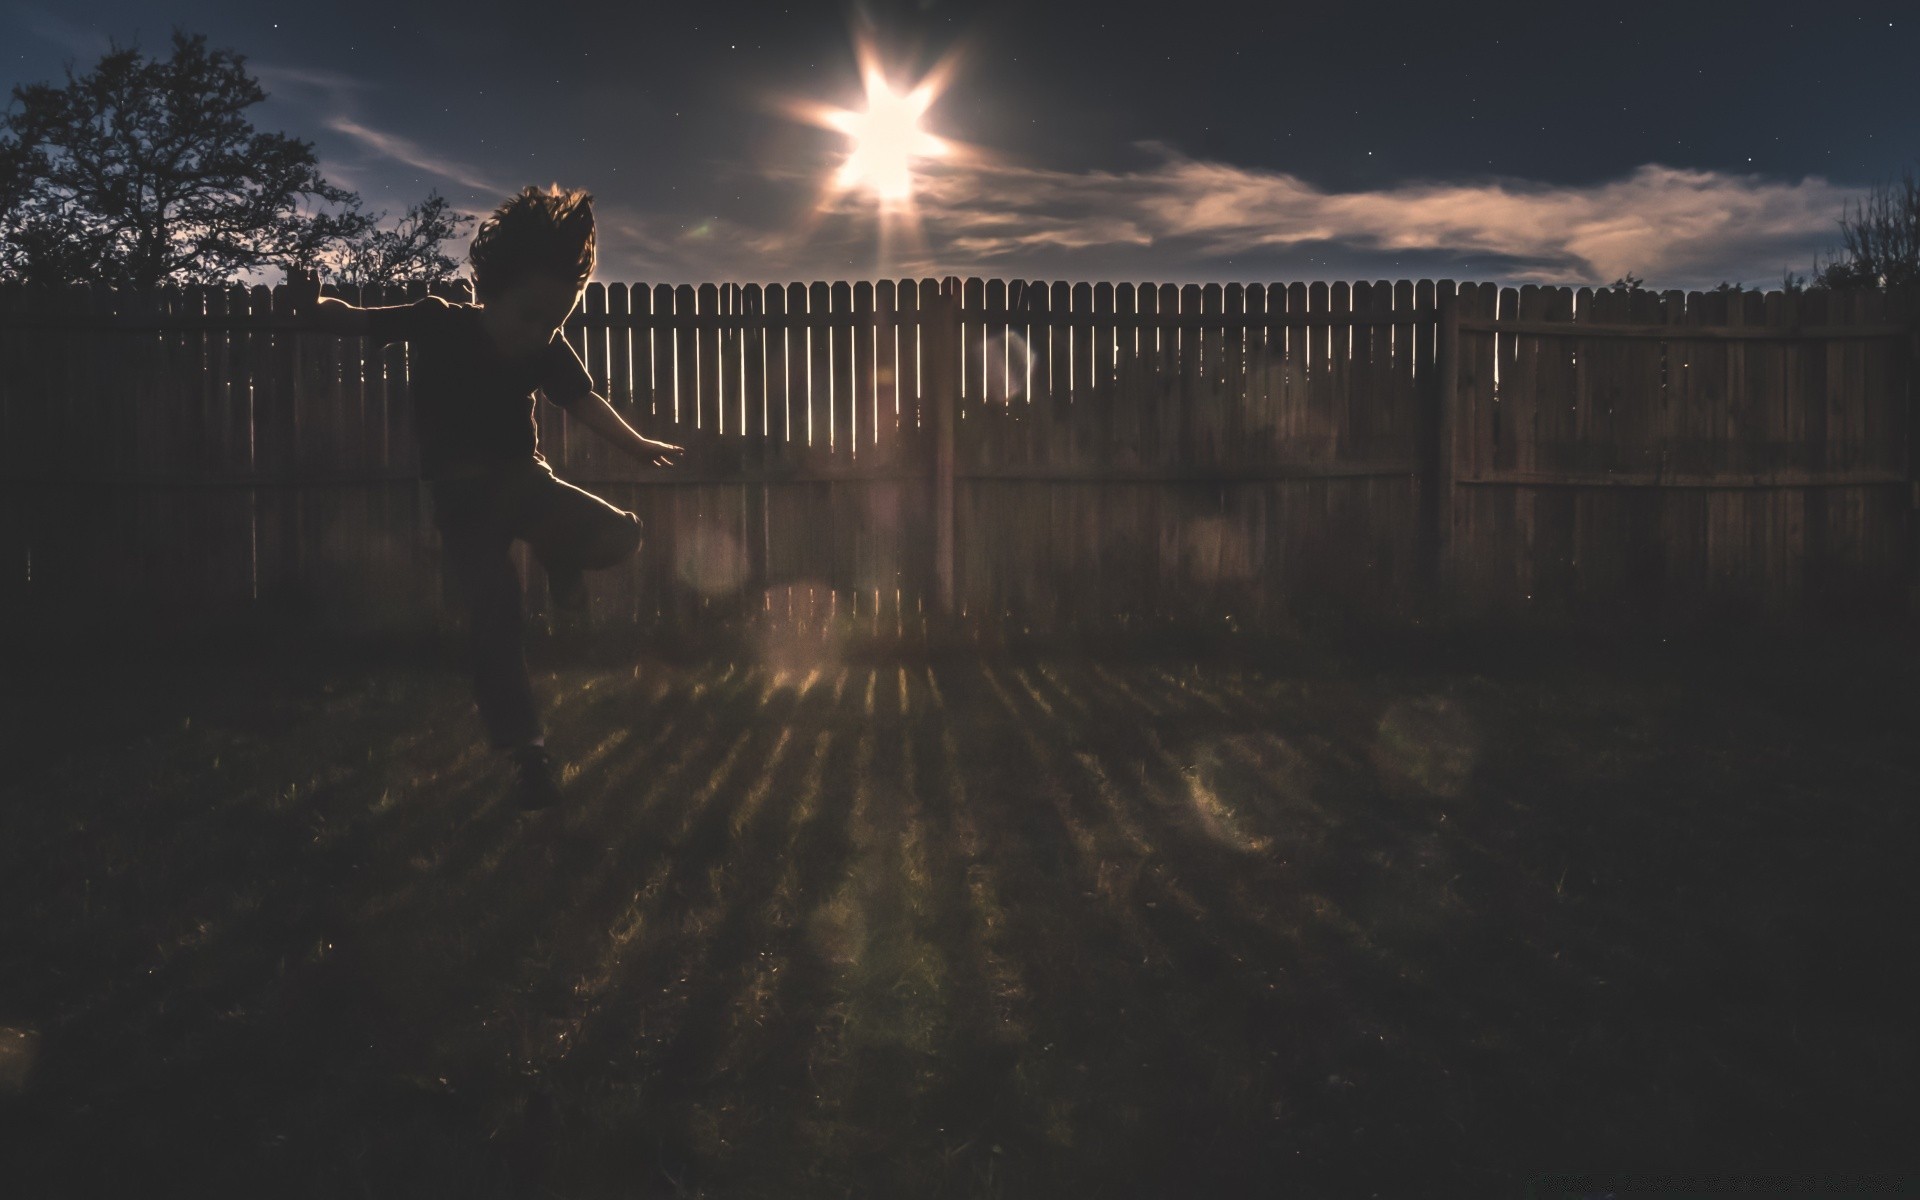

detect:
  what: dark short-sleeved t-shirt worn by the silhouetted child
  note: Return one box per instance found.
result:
[367,296,593,480]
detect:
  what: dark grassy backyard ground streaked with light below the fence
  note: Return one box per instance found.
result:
[0,614,1920,1198]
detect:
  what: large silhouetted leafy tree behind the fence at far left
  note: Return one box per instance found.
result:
[0,31,372,288]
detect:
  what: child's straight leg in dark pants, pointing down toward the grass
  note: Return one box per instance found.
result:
[442,503,541,749]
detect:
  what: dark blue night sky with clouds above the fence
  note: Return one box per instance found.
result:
[0,0,1920,286]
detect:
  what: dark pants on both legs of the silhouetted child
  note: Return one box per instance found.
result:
[432,459,641,749]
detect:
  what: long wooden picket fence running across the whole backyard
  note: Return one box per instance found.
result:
[0,278,1916,636]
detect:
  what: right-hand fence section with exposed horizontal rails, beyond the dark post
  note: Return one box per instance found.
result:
[1453,288,1912,616]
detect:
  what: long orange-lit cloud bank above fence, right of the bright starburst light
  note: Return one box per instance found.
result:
[791,146,1855,284]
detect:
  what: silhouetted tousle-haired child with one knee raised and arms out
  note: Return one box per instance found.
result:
[292,186,682,808]
